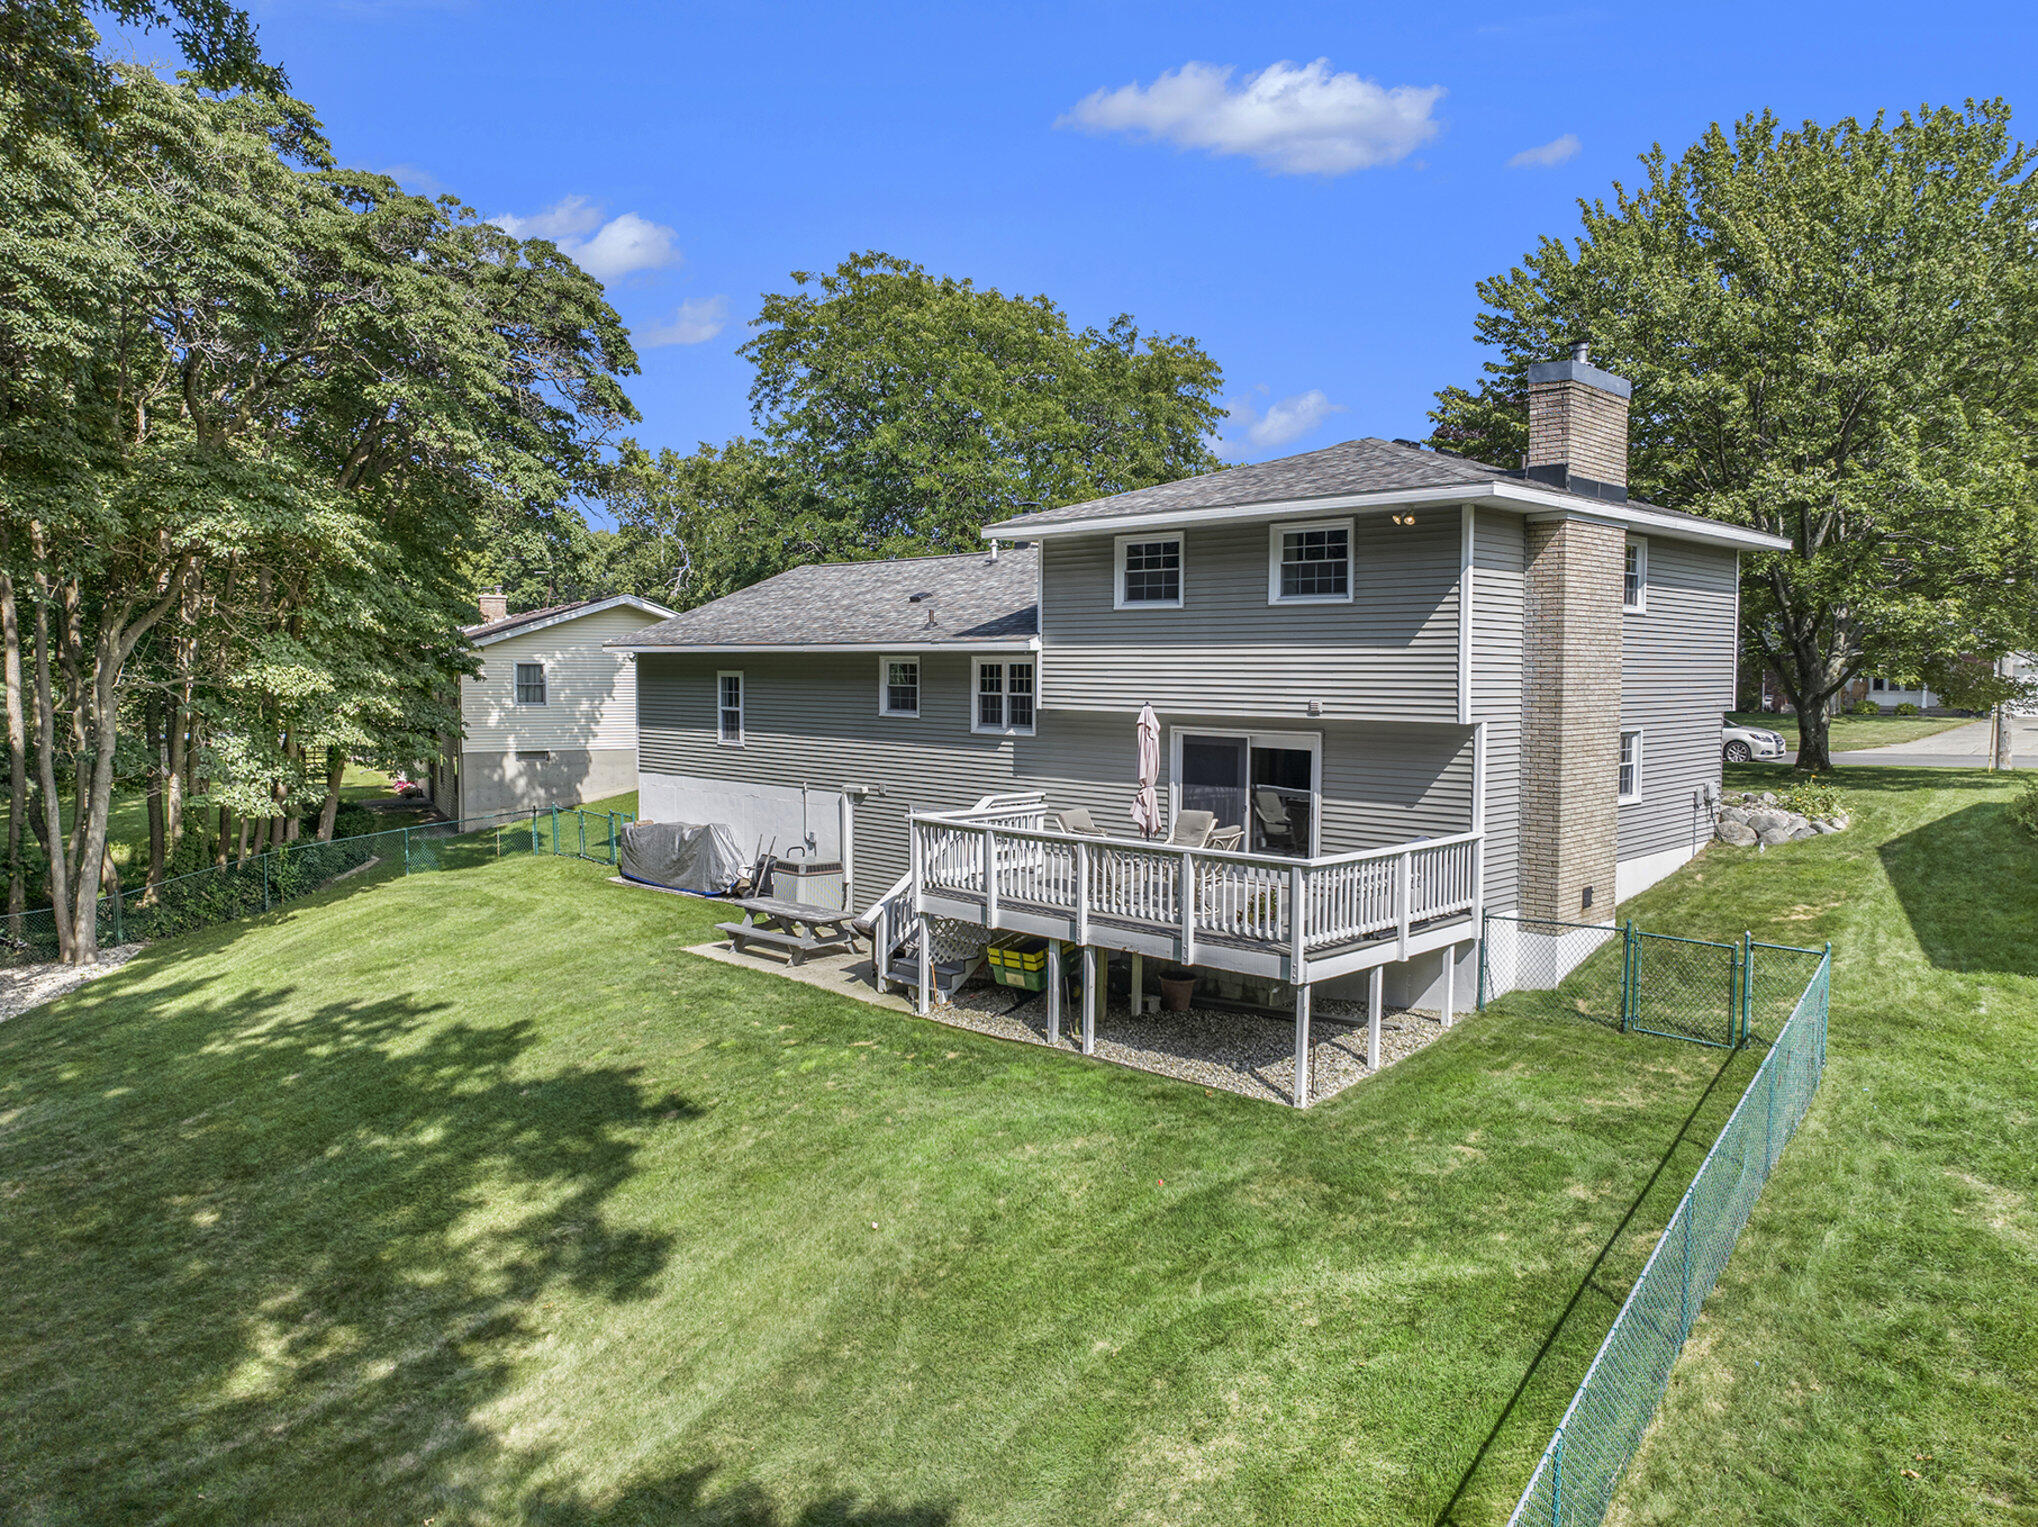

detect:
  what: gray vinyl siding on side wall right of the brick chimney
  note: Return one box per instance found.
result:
[1618,538,1738,858]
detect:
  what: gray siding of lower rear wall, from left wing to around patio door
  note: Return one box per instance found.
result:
[638,652,1473,907]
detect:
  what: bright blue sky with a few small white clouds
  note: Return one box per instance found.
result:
[206,0,2038,477]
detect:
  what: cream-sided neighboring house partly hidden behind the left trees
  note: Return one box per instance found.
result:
[432,593,673,818]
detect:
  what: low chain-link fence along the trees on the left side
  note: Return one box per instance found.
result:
[0,805,636,964]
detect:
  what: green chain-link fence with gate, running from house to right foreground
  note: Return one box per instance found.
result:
[1482,928,1832,1527]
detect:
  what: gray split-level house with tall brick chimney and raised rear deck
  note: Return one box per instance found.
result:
[618,351,1789,1051]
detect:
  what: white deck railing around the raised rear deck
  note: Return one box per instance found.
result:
[911,797,1484,966]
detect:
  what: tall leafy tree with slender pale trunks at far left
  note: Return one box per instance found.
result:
[0,38,636,960]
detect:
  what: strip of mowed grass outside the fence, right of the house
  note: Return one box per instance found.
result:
[1612,767,2038,1525]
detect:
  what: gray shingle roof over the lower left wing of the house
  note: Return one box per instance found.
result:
[622,546,1039,646]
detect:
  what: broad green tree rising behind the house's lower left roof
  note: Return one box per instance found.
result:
[742,253,1223,557]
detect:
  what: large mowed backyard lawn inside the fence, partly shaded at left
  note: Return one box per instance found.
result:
[0,839,1747,1527]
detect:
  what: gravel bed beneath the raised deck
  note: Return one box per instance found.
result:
[929,987,1443,1103]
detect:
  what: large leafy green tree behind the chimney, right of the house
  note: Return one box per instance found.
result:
[1431,100,2038,769]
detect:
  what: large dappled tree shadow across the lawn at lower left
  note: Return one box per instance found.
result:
[0,981,709,1523]
